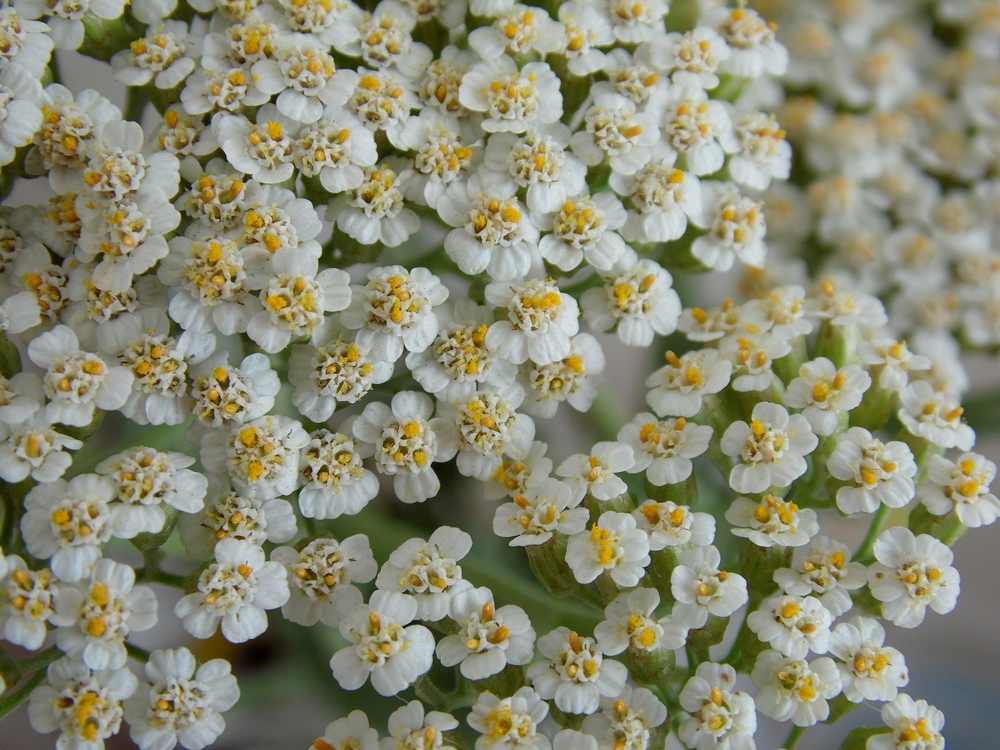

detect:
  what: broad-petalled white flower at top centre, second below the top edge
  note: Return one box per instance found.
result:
[458,55,563,133]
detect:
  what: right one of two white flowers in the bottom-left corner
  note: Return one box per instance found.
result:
[123,648,240,750]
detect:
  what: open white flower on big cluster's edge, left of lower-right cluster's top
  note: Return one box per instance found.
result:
[580,252,681,347]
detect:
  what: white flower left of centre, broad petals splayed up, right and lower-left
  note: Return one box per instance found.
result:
[247,260,351,354]
